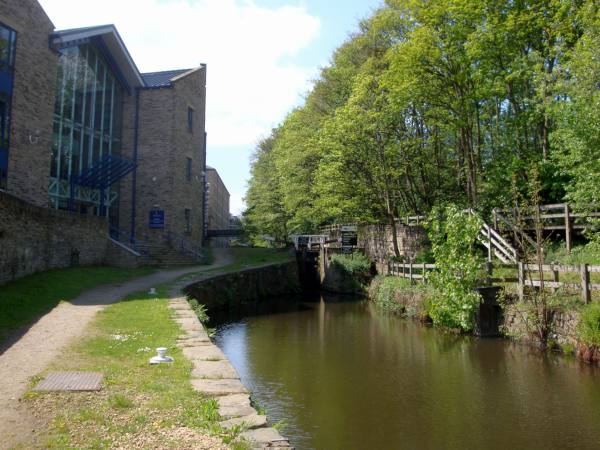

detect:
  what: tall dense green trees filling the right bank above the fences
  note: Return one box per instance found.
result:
[244,0,600,246]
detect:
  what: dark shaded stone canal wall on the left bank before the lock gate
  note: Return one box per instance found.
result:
[184,261,300,312]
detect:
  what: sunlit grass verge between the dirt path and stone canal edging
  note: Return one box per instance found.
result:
[27,288,246,450]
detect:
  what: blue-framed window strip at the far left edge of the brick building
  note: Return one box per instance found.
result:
[0,23,17,189]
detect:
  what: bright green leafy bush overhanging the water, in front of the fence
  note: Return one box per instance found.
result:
[428,205,481,331]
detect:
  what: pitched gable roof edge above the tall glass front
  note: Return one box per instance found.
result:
[50,25,144,87]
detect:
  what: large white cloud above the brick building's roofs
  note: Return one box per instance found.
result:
[41,0,320,147]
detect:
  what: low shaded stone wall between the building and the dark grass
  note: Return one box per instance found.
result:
[0,192,108,283]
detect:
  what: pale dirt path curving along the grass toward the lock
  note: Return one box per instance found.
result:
[0,251,230,448]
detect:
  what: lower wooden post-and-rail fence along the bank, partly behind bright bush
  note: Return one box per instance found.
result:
[388,262,600,303]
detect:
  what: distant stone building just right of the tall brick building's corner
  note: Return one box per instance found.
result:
[206,166,231,247]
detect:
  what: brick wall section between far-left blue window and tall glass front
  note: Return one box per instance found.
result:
[0,0,58,206]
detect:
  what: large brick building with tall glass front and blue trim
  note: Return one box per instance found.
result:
[0,0,206,282]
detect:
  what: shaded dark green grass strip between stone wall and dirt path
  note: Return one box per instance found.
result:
[0,266,156,342]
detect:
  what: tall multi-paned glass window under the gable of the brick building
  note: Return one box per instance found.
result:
[50,43,123,215]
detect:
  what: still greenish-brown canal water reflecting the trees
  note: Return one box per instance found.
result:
[216,300,600,450]
